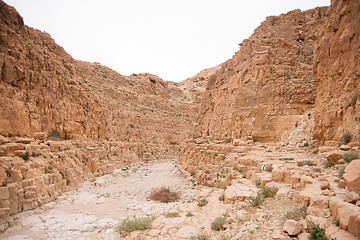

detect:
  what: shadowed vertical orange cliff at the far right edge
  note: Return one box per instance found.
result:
[314,0,360,143]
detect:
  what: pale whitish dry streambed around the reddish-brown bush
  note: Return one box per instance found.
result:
[0,161,194,240]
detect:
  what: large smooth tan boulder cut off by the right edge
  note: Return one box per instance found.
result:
[343,159,360,194]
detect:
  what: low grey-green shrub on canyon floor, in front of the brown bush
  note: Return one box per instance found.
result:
[115,218,152,237]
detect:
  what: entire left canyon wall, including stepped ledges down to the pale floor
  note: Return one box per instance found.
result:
[0,1,202,232]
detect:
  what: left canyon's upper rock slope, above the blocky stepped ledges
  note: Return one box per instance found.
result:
[0,2,195,148]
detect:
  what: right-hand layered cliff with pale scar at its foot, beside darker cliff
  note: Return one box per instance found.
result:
[195,8,326,142]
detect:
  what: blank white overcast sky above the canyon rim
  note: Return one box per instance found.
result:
[5,0,330,81]
